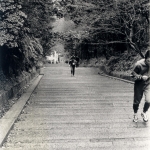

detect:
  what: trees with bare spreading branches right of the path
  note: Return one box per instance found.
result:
[56,0,149,59]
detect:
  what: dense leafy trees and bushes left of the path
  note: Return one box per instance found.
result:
[0,0,55,88]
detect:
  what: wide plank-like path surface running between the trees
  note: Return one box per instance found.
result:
[3,65,150,150]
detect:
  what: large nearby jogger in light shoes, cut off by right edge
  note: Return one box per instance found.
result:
[132,50,150,122]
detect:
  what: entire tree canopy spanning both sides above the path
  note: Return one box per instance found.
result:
[0,0,149,87]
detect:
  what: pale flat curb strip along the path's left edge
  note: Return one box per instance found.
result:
[0,75,43,147]
